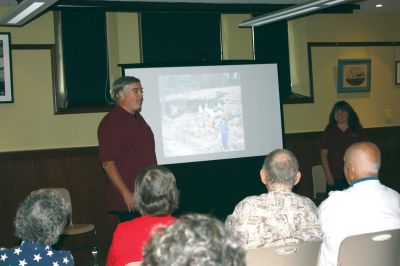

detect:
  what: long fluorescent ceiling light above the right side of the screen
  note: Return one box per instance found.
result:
[239,0,349,28]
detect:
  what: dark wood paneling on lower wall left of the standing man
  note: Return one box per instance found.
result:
[0,147,117,264]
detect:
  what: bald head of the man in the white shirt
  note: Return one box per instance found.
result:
[344,142,381,182]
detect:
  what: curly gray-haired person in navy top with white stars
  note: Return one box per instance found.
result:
[0,190,74,266]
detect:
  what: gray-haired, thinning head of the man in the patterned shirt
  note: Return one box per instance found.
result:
[263,149,299,187]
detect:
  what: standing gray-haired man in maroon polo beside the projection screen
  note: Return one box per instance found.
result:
[97,77,157,222]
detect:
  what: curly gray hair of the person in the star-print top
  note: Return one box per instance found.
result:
[14,190,71,245]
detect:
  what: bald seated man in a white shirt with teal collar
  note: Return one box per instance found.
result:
[319,142,400,266]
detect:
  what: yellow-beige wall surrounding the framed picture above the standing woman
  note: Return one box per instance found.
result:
[284,13,400,133]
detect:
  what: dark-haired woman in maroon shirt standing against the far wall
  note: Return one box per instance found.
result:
[321,101,365,192]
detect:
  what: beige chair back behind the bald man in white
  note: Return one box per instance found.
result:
[337,229,400,266]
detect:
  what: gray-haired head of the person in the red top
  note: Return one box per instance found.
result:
[134,165,179,216]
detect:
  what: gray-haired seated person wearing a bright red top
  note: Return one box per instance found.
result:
[106,165,179,266]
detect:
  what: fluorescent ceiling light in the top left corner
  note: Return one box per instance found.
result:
[0,0,57,26]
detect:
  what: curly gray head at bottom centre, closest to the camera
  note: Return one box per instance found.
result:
[142,214,245,266]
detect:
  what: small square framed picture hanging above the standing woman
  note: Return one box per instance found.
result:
[337,59,371,93]
